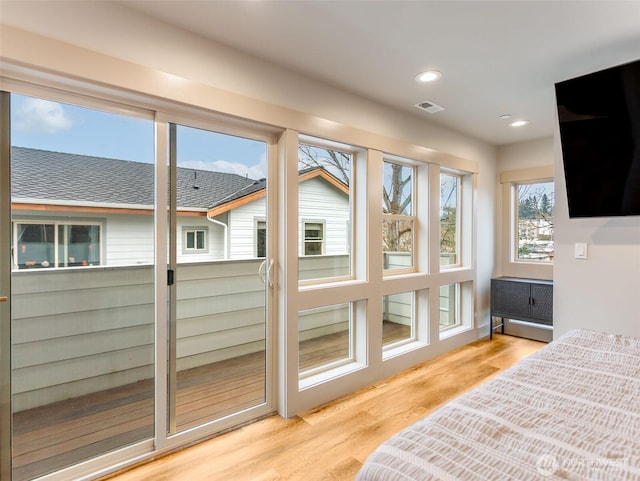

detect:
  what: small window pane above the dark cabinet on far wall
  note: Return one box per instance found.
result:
[514,181,555,262]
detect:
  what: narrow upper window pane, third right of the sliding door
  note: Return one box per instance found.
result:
[440,173,461,266]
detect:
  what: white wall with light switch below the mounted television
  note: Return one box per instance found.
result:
[553,129,640,338]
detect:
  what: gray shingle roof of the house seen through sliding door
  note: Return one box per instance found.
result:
[11,147,265,208]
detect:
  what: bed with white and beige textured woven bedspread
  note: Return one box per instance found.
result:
[356,330,640,481]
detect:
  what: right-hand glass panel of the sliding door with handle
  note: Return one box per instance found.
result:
[168,124,272,434]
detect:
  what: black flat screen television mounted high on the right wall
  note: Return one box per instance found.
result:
[555,60,640,217]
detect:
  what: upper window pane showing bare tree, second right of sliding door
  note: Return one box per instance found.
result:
[382,161,415,270]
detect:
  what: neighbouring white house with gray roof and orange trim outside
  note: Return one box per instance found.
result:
[11,147,350,269]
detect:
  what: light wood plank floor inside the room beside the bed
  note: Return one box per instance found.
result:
[109,334,544,481]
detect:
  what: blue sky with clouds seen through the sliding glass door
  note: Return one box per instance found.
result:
[11,94,266,179]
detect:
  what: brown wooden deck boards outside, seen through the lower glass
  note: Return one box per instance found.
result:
[13,323,408,481]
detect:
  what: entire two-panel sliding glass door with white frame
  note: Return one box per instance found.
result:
[0,92,274,481]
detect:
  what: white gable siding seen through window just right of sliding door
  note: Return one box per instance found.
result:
[298,177,350,256]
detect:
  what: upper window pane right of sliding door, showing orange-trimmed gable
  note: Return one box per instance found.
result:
[298,144,353,280]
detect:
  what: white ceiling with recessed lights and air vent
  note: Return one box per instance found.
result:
[121,0,640,145]
